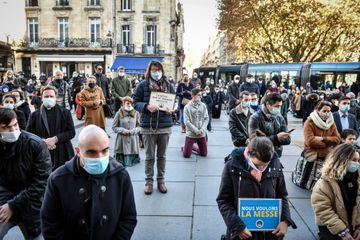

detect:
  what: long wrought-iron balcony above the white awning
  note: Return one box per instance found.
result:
[23,38,112,48]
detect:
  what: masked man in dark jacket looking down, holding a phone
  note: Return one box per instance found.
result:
[249,93,291,156]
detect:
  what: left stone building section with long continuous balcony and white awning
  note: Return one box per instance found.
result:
[15,0,112,76]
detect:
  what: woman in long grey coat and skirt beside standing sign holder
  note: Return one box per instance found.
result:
[112,96,140,167]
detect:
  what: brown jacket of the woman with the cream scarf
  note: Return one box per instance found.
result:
[304,118,340,158]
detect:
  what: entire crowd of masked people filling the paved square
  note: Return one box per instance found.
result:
[0,61,360,240]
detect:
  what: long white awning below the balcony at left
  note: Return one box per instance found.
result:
[37,54,104,62]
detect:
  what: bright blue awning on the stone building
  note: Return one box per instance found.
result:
[111,57,163,74]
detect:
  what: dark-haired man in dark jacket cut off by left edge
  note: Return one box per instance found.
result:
[0,108,51,240]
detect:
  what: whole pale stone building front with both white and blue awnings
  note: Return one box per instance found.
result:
[15,0,184,78]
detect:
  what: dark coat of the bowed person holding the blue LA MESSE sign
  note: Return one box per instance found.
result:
[216,147,296,240]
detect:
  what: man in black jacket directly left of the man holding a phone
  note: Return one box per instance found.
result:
[229,91,251,147]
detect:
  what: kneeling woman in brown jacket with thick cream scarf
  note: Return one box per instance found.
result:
[293,101,340,189]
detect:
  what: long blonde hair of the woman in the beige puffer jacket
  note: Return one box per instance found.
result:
[321,143,356,181]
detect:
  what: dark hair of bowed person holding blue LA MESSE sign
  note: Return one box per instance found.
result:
[247,130,275,163]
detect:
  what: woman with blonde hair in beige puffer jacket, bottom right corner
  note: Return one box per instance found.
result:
[311,144,360,240]
